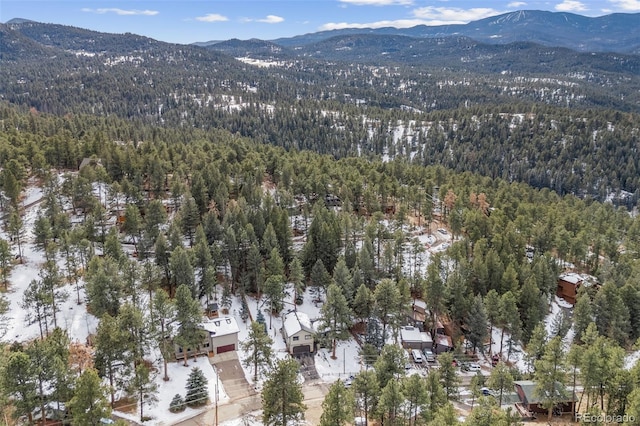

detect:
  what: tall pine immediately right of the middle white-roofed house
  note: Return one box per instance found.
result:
[319,283,351,359]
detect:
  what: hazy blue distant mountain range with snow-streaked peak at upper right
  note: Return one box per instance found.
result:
[197,10,640,54]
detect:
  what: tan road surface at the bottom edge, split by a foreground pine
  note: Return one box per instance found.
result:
[176,380,329,426]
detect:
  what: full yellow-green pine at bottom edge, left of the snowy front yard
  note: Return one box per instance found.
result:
[69,368,111,426]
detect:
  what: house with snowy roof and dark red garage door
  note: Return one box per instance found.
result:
[174,317,240,359]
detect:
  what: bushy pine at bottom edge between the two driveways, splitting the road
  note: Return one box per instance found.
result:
[262,359,307,426]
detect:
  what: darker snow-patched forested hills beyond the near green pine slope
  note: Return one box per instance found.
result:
[0,23,640,203]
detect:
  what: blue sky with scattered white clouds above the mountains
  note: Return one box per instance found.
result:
[0,0,640,44]
